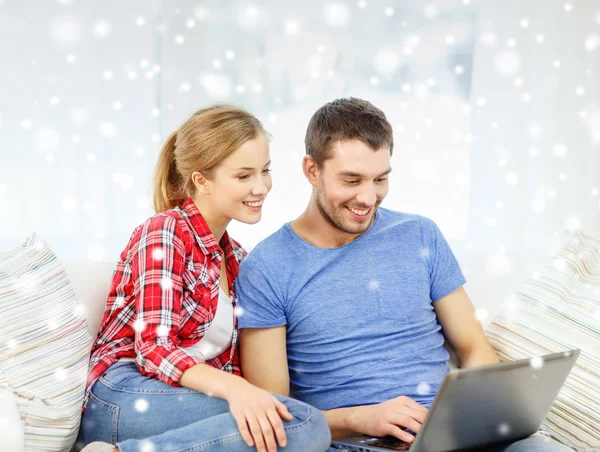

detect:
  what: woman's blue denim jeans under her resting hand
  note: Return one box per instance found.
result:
[80,362,331,452]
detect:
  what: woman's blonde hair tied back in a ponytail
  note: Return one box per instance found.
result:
[154,104,267,213]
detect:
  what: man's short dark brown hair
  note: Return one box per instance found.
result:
[304,97,394,168]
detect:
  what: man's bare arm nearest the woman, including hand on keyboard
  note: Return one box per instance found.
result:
[240,326,427,442]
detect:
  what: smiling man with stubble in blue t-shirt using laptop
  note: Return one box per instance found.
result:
[237,98,568,451]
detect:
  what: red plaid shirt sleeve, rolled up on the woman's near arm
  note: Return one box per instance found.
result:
[131,215,203,386]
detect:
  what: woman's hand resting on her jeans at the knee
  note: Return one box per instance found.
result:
[225,378,293,452]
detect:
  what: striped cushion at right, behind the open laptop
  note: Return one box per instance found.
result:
[487,231,600,451]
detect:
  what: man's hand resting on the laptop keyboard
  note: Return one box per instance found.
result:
[349,396,429,443]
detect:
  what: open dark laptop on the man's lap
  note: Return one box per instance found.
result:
[332,350,579,452]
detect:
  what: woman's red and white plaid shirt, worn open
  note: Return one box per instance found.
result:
[86,198,246,406]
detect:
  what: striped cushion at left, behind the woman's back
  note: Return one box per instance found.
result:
[0,234,92,451]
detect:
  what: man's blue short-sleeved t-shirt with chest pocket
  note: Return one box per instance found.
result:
[236,208,465,410]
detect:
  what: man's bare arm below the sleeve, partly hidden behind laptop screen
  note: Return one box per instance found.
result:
[433,287,499,368]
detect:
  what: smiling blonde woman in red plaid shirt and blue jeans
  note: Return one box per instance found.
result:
[81,105,331,452]
